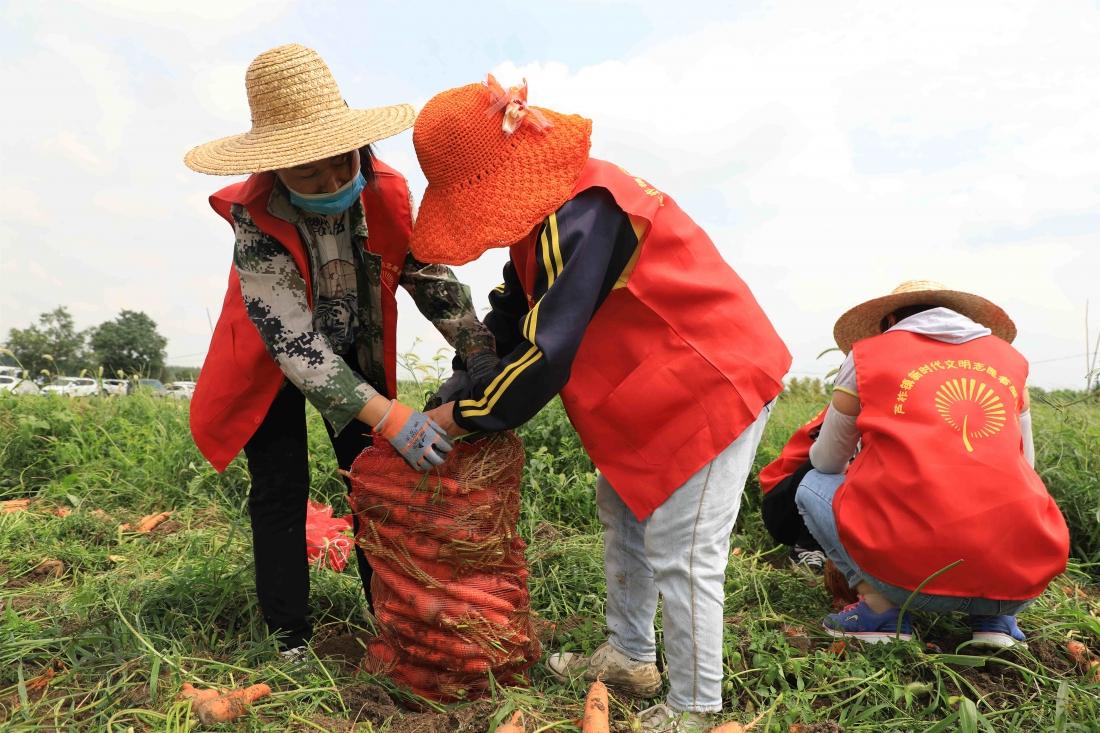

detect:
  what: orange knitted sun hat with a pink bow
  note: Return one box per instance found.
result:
[409,74,592,265]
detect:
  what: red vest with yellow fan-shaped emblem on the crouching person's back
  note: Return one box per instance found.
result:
[833,331,1069,601]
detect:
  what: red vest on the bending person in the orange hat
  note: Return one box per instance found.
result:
[512,158,791,519]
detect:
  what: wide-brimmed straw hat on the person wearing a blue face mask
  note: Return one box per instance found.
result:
[184,43,416,176]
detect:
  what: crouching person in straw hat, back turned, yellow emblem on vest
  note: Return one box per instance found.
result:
[795,281,1069,647]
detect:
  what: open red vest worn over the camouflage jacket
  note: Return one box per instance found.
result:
[190,158,413,471]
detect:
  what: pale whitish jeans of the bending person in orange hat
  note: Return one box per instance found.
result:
[596,405,771,712]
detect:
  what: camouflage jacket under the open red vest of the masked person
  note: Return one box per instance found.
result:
[232,184,494,433]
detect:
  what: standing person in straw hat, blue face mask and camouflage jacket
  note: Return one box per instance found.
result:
[185,45,496,652]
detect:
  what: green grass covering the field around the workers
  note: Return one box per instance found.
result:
[0,384,1100,733]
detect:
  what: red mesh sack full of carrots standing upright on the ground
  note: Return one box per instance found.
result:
[351,433,539,702]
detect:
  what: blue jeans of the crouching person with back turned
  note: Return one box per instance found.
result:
[794,470,1034,616]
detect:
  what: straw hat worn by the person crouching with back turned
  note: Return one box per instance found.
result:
[833,280,1016,353]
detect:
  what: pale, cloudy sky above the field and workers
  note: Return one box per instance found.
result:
[0,0,1100,386]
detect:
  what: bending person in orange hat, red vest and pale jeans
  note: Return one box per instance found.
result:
[413,76,791,730]
